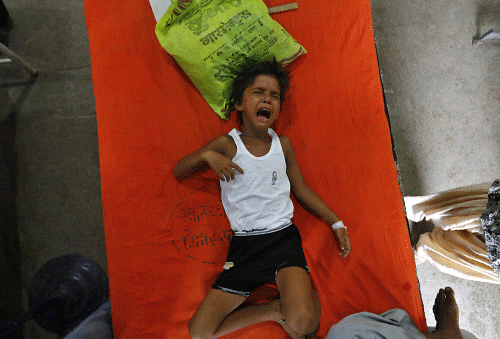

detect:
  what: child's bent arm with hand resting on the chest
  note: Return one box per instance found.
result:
[174,135,243,181]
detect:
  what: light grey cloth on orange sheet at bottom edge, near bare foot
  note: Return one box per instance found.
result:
[326,308,425,339]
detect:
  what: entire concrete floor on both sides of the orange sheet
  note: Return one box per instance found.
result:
[0,0,500,339]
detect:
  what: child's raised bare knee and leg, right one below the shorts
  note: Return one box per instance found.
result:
[276,267,321,338]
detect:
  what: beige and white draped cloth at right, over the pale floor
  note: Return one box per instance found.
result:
[404,183,500,284]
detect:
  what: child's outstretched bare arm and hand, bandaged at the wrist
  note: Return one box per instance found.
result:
[280,136,351,257]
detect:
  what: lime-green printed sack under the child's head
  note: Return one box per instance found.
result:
[156,0,306,118]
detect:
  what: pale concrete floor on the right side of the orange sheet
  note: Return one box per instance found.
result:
[372,0,500,339]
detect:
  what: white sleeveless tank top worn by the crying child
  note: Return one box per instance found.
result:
[220,128,293,236]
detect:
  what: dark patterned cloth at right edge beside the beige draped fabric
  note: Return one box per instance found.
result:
[481,179,500,275]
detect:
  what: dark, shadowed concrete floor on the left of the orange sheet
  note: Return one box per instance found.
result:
[0,0,107,339]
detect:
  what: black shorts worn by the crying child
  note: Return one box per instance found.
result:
[212,224,309,296]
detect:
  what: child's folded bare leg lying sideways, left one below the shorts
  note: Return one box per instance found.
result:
[189,289,281,339]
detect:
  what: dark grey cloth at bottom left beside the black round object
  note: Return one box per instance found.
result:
[64,300,113,339]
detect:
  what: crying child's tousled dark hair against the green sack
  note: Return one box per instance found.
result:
[226,59,290,123]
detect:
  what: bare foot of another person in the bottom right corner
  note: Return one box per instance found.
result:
[424,287,463,339]
